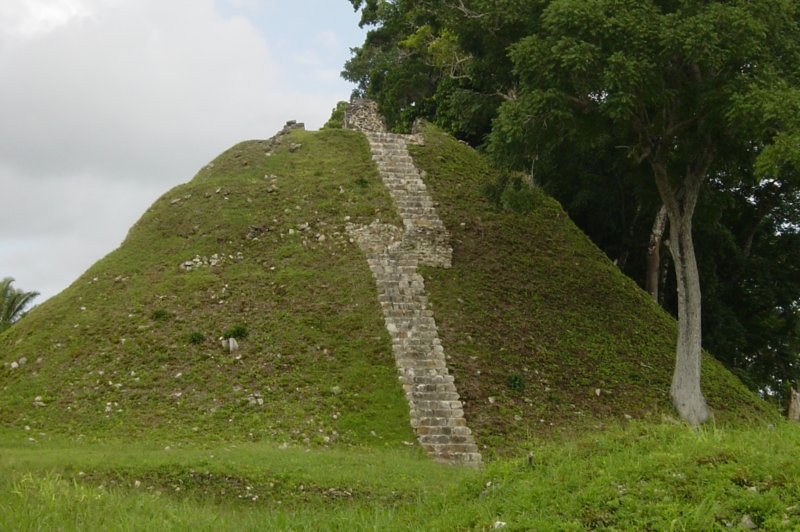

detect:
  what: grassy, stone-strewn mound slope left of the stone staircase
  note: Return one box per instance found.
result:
[0,130,413,446]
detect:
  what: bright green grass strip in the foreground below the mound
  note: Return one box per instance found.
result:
[0,422,800,530]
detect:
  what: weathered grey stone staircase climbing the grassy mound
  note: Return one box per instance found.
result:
[347,101,481,466]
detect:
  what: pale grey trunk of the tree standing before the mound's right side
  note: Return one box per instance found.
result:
[669,210,709,427]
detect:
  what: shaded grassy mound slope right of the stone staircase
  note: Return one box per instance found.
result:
[412,122,776,450]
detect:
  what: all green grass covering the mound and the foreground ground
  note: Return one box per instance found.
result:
[0,121,800,531]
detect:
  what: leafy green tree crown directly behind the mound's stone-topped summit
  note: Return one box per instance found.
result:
[342,0,544,139]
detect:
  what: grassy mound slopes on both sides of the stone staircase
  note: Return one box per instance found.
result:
[0,120,774,451]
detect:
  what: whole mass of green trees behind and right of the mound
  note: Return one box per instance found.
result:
[344,0,800,423]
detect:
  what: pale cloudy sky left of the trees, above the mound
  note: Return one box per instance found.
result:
[0,0,364,303]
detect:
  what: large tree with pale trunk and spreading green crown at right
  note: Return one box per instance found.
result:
[490,0,800,426]
